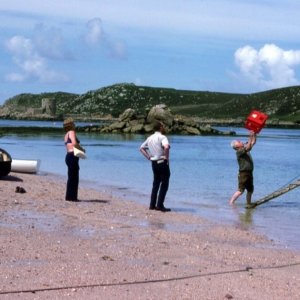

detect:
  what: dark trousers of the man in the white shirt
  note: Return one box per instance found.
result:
[150,160,171,208]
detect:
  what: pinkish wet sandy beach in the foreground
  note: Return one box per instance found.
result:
[0,173,300,300]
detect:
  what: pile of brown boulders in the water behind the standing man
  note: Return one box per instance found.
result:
[85,104,235,135]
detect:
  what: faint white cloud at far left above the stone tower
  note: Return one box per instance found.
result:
[6,36,68,83]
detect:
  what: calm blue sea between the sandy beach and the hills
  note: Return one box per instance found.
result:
[0,120,300,250]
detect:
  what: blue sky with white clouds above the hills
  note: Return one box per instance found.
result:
[0,0,300,104]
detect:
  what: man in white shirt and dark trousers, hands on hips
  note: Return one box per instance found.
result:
[140,122,171,212]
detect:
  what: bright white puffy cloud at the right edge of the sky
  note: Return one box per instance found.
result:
[234,44,300,89]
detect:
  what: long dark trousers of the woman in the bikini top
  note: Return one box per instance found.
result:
[66,152,79,201]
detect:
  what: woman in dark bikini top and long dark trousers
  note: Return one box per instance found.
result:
[64,118,83,201]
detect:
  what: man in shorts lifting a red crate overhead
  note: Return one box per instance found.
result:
[229,131,256,206]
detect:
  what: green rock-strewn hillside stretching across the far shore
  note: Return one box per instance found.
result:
[0,84,300,123]
